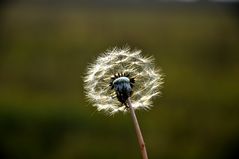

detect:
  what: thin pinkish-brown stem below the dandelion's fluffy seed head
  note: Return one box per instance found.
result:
[127,98,148,159]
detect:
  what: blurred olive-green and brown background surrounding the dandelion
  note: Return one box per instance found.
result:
[0,0,239,159]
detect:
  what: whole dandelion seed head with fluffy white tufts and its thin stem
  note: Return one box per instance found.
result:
[84,48,163,159]
